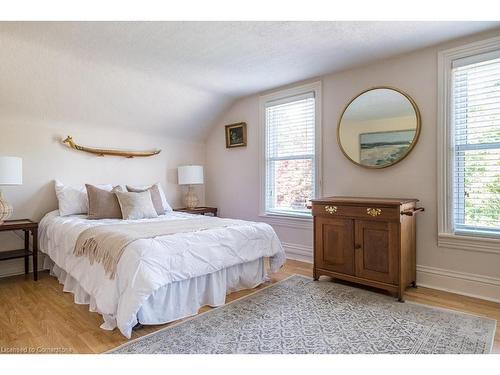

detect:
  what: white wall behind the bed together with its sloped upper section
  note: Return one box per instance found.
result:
[0,30,208,276]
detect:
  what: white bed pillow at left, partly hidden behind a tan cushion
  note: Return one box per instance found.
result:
[55,181,113,216]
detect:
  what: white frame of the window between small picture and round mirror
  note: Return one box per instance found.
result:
[259,81,323,220]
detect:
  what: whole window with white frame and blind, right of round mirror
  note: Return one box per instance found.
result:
[438,38,500,252]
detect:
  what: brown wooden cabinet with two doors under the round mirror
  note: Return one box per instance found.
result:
[312,197,423,301]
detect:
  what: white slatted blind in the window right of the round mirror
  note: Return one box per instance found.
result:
[452,52,500,236]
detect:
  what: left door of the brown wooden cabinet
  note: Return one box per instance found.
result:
[314,217,354,275]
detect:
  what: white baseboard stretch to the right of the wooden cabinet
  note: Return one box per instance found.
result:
[417,265,500,302]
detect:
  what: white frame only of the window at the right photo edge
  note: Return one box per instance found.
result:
[437,37,500,254]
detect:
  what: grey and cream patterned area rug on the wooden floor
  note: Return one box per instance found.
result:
[111,275,496,354]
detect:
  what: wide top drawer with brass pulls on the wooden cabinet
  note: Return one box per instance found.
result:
[312,203,400,221]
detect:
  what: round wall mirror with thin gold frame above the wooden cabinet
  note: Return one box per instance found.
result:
[337,87,420,168]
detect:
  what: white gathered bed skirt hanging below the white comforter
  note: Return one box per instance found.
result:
[44,255,267,330]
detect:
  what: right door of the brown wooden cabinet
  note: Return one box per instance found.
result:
[355,220,399,284]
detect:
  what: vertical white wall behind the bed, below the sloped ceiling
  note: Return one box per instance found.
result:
[0,116,205,276]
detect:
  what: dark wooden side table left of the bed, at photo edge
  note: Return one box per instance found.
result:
[0,219,38,281]
